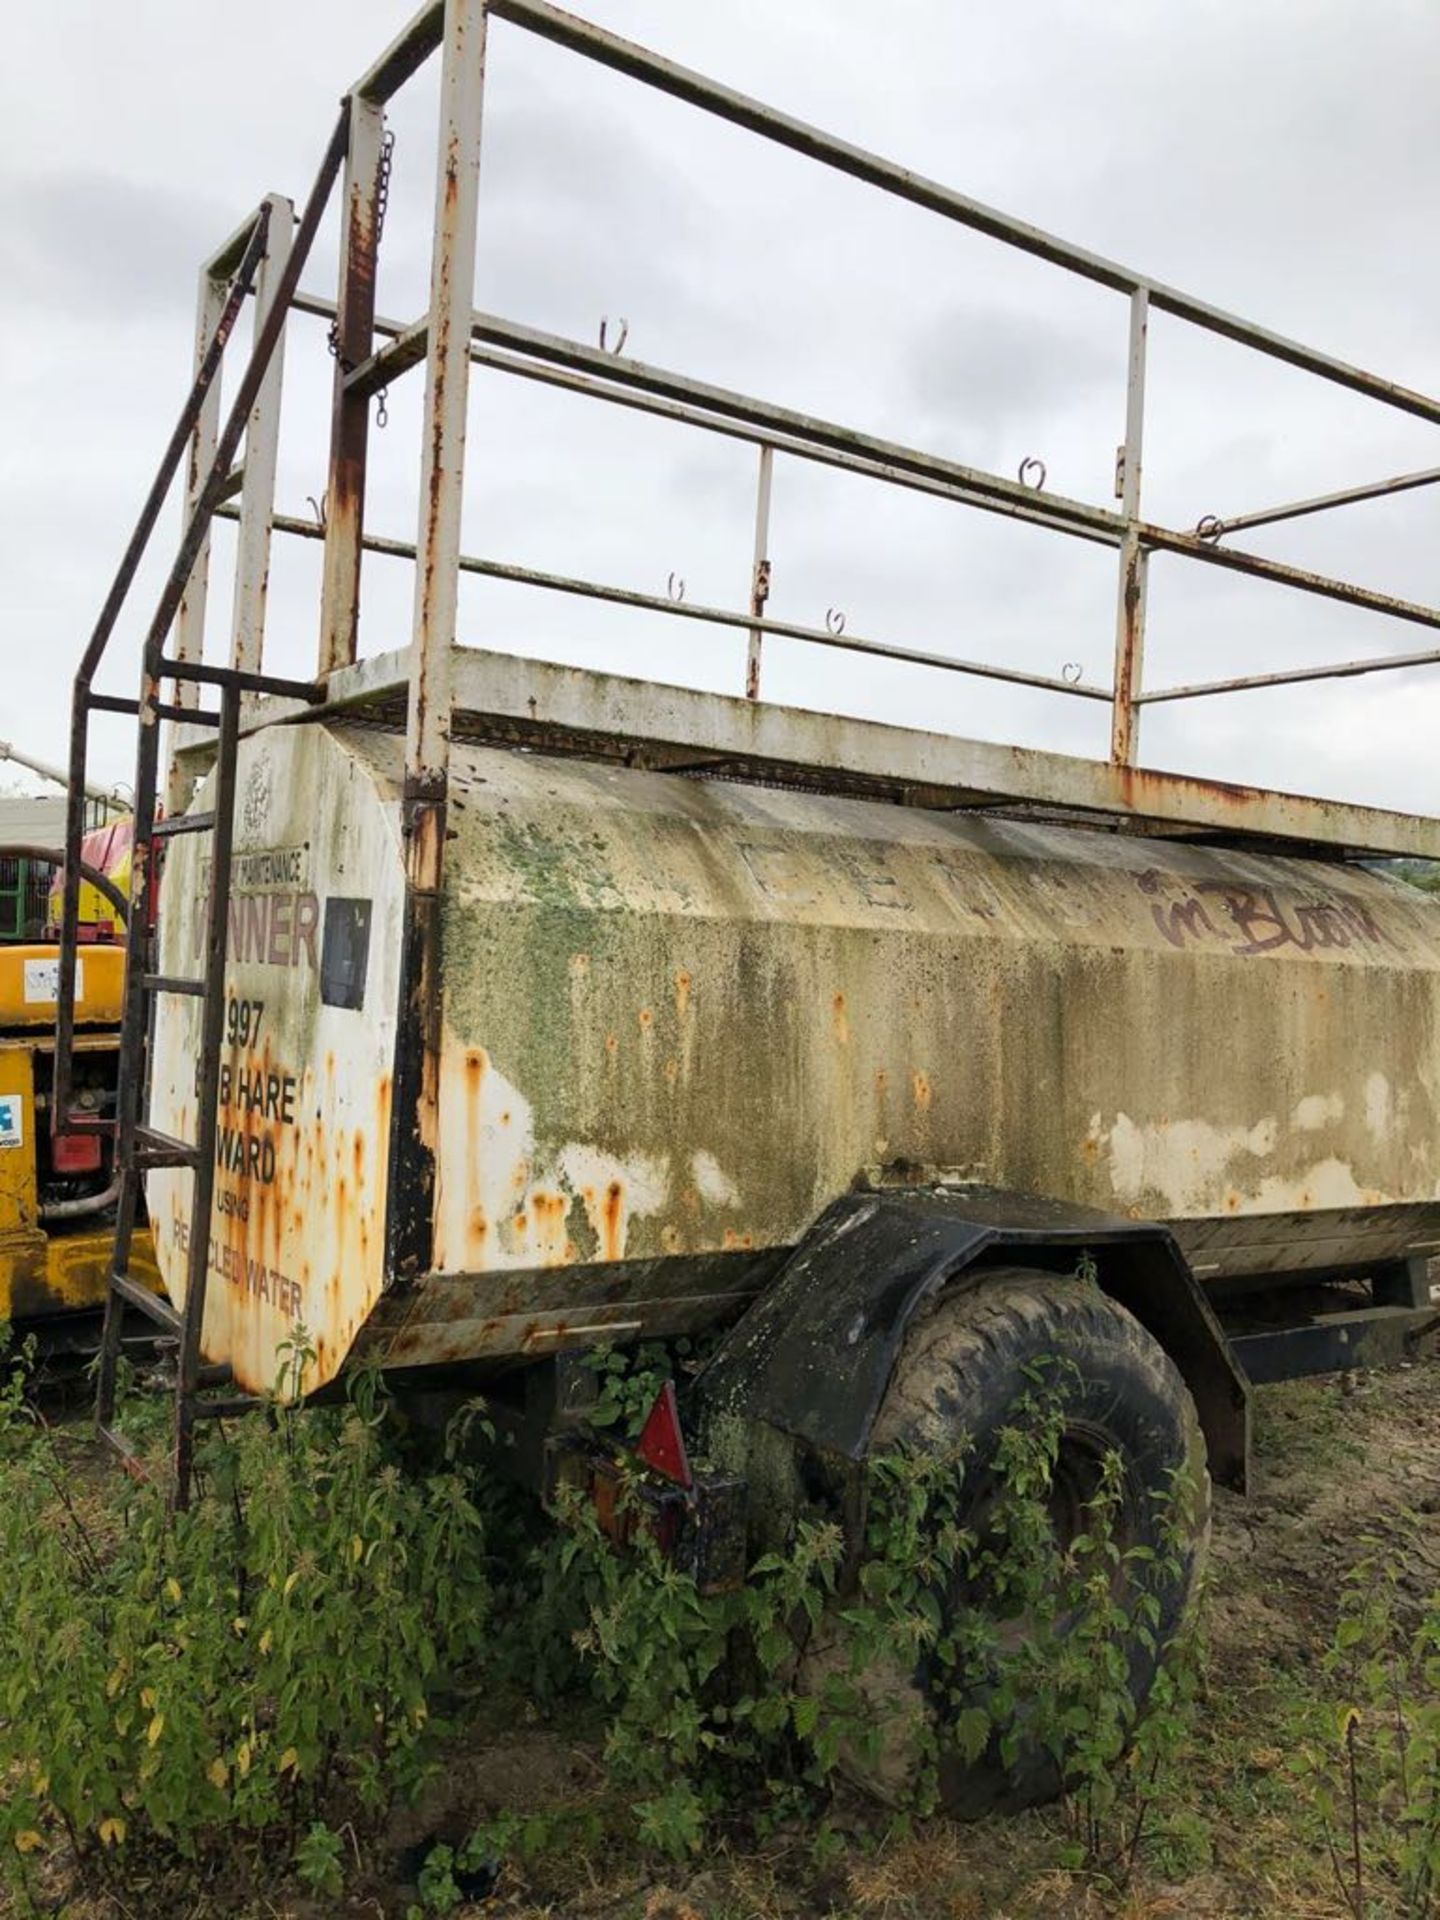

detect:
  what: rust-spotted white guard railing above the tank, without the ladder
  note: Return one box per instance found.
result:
[163,0,1440,879]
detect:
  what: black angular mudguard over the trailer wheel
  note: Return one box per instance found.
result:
[693,1187,1250,1492]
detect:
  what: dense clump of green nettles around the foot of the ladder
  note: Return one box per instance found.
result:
[0,1348,490,1891]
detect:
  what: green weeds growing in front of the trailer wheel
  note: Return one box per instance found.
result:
[534,1363,1198,1880]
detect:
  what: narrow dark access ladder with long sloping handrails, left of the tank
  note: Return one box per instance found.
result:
[52,102,349,1507]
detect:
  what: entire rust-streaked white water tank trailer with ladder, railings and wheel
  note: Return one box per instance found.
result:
[56,0,1440,1805]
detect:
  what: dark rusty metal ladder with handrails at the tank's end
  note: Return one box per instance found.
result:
[52,111,348,1507]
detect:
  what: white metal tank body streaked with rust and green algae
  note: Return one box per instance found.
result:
[148,720,1440,1390]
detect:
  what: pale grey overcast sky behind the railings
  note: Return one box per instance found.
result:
[0,0,1440,810]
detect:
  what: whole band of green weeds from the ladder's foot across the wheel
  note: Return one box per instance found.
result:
[0,1320,1194,1914]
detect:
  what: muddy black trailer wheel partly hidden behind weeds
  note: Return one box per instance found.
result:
[801,1267,1210,1818]
